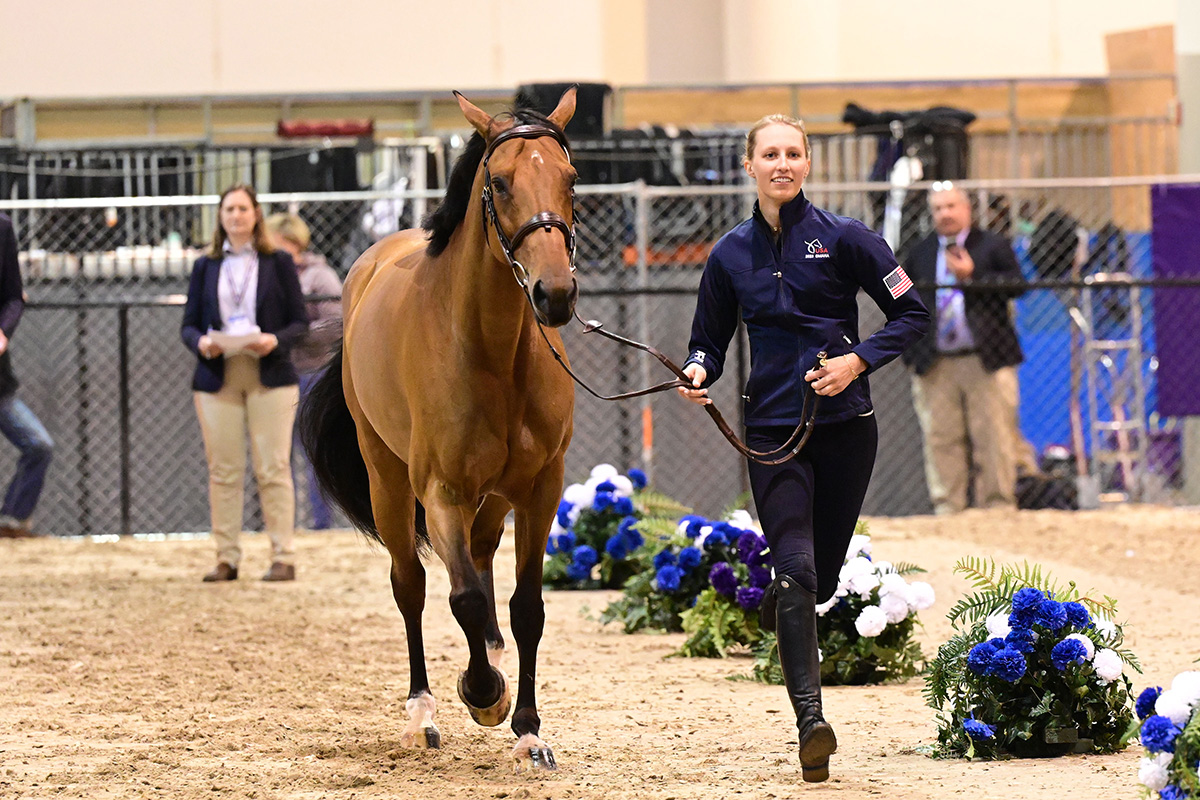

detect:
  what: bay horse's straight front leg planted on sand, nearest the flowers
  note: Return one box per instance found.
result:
[509,461,563,770]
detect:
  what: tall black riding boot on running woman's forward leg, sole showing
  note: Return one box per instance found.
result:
[775,575,838,783]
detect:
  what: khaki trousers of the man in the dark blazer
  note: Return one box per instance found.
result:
[912,355,1018,513]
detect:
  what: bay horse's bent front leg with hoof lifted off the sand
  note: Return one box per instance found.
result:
[425,482,511,726]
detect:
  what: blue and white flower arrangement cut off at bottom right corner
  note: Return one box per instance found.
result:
[1126,670,1200,800]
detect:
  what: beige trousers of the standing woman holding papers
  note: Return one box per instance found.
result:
[193,355,300,566]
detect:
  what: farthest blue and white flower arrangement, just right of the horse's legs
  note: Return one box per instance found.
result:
[542,464,688,589]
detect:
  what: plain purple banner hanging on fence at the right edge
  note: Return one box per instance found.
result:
[1150,184,1200,416]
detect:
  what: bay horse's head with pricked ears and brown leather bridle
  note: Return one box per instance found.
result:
[455,88,580,327]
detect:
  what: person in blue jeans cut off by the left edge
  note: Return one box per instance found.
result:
[0,213,54,539]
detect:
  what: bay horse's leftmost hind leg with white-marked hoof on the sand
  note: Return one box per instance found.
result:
[359,427,442,750]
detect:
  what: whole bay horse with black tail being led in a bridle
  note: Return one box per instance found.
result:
[301,89,578,769]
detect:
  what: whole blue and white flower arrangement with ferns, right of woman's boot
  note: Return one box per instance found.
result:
[925,559,1137,758]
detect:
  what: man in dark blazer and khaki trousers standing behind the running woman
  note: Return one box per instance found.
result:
[904,181,1025,513]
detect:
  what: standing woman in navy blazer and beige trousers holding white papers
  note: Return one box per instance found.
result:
[181,185,308,582]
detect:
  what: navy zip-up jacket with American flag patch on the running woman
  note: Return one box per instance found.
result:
[684,192,930,426]
